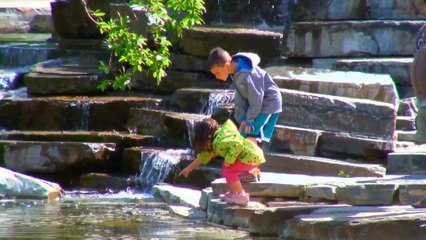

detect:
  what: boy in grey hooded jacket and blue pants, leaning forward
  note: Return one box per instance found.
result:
[207,47,282,143]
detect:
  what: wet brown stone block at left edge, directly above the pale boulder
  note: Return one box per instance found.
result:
[0,140,116,174]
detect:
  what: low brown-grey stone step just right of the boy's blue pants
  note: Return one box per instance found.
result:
[265,125,400,164]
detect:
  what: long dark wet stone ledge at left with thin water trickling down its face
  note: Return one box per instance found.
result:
[0,96,163,131]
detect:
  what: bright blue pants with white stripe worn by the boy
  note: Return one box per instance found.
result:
[241,113,280,142]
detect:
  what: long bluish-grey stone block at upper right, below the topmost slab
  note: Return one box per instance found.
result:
[282,20,424,58]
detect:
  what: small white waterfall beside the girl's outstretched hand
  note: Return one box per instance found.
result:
[134,149,191,192]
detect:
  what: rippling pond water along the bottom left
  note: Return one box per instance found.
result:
[0,191,272,239]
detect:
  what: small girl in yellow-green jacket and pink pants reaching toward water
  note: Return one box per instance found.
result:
[179,118,265,205]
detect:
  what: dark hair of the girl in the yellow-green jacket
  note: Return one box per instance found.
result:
[192,118,219,154]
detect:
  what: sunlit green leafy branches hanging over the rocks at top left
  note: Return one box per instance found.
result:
[90,0,205,91]
